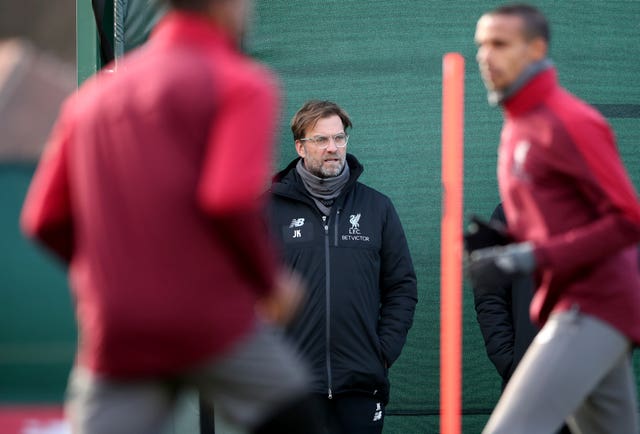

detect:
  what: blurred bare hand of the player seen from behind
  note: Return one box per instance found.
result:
[256,269,305,326]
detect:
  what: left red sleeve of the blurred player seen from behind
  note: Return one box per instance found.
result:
[20,103,74,263]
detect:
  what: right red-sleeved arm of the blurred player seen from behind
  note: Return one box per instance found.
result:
[198,69,278,292]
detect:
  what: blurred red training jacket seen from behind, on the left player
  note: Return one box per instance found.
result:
[21,12,279,376]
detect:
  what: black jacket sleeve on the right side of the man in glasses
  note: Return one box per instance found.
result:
[378,199,418,367]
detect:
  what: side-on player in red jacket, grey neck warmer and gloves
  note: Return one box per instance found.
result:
[467,5,640,434]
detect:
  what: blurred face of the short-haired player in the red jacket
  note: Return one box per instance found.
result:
[475,15,544,91]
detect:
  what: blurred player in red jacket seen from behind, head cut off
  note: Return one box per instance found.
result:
[21,0,324,434]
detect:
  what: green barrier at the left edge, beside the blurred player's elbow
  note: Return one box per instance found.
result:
[0,165,75,402]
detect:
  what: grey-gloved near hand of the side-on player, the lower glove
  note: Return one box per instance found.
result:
[465,242,536,293]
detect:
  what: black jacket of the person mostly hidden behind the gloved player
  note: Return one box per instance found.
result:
[474,204,538,389]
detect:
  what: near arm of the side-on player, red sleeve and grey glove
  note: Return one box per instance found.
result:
[468,119,640,286]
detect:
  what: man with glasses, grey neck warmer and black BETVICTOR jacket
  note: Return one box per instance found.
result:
[270,100,417,434]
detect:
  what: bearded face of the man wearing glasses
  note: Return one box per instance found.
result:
[296,115,347,178]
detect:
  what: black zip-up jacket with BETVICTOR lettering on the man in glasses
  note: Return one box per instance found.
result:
[269,154,417,403]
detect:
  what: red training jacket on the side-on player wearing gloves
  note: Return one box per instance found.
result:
[498,69,640,343]
